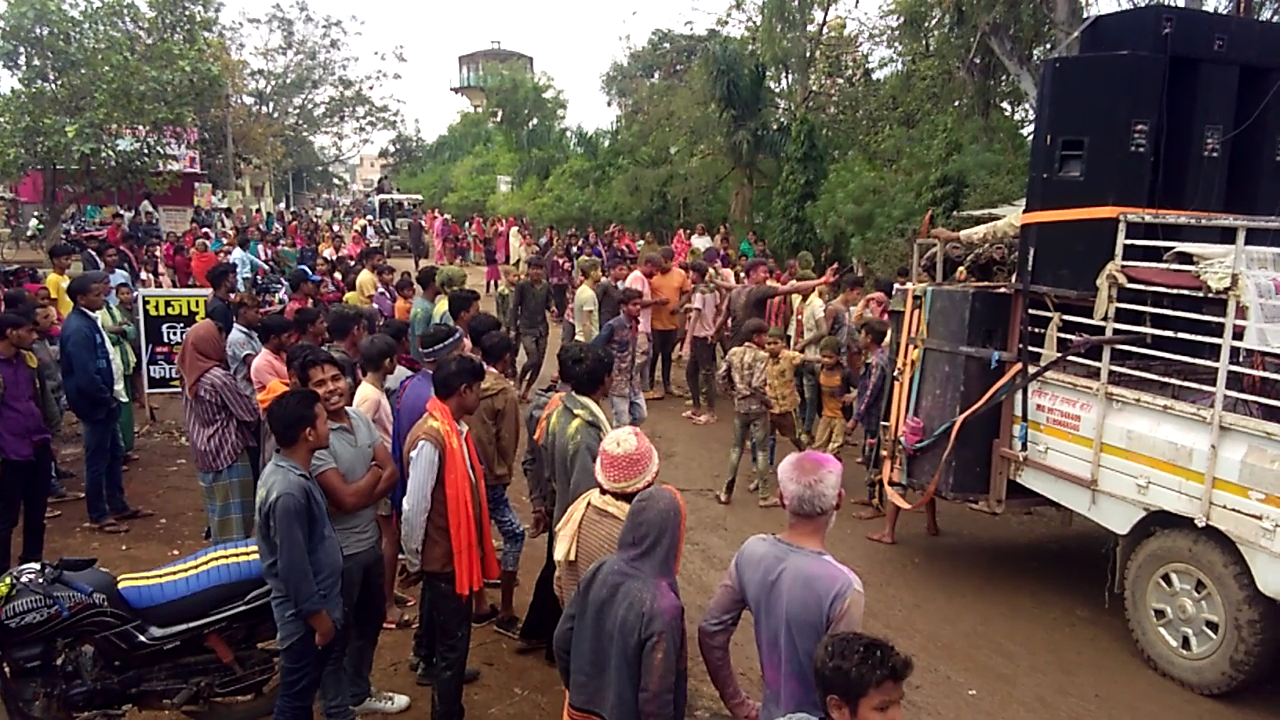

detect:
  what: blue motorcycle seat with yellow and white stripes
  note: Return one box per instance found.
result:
[116,539,266,628]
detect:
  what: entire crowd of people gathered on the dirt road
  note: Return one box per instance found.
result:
[0,203,952,720]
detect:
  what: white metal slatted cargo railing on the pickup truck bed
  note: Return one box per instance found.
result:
[1023,213,1280,516]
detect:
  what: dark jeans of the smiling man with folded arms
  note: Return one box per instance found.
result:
[320,543,387,720]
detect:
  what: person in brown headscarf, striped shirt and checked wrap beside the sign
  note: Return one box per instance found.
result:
[178,318,259,543]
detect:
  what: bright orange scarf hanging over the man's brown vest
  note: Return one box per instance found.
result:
[426,396,499,597]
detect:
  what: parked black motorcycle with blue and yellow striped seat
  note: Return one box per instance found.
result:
[0,539,279,720]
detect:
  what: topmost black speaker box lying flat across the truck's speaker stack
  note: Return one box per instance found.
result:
[1079,5,1280,68]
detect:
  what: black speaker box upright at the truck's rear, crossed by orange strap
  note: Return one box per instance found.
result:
[906,284,1012,500]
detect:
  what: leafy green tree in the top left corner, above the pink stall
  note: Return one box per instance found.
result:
[0,0,224,217]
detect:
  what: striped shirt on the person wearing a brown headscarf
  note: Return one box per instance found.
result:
[182,368,259,473]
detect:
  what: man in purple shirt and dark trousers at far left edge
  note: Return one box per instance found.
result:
[0,309,54,573]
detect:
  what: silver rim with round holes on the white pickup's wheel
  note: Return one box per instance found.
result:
[1147,562,1226,660]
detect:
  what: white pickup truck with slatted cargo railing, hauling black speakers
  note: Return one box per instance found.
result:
[987,214,1280,696]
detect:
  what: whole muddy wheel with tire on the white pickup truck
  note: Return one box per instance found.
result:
[1124,528,1280,696]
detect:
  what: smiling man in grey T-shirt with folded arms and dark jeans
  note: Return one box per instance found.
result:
[291,350,410,720]
